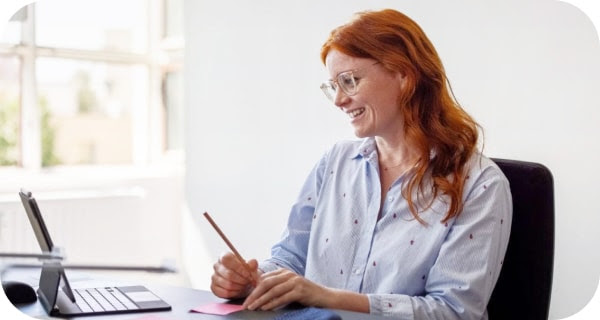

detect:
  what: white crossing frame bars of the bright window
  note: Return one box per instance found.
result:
[0,0,184,171]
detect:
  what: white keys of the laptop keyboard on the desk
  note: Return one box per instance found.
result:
[74,287,139,313]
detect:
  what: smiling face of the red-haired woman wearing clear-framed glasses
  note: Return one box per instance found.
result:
[325,50,405,139]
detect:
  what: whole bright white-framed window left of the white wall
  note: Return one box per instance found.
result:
[0,0,184,169]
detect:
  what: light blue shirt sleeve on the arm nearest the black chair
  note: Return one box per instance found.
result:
[368,166,512,320]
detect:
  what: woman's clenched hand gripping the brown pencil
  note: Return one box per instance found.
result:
[210,252,260,299]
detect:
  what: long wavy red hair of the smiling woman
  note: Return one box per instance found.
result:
[321,9,480,224]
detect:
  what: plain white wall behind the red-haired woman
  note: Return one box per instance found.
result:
[184,0,600,319]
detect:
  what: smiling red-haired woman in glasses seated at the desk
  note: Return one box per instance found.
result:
[211,9,512,319]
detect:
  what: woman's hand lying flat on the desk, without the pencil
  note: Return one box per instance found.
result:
[243,269,332,310]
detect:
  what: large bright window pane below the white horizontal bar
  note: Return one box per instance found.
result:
[36,58,148,165]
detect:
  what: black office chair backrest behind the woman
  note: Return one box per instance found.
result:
[488,159,554,320]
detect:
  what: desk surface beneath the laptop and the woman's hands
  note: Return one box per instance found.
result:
[3,270,388,320]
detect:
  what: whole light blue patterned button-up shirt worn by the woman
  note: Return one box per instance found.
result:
[260,138,512,320]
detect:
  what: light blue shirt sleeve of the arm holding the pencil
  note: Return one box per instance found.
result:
[259,154,327,275]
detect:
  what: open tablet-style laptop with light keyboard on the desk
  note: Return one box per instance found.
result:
[19,189,171,316]
